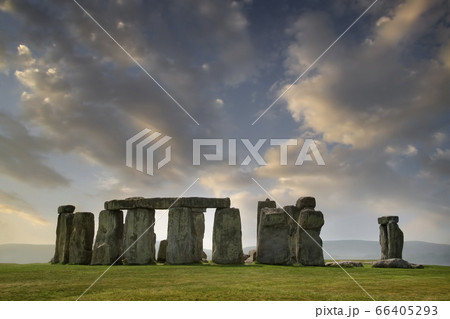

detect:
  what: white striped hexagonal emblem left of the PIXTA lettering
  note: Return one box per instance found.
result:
[126,128,172,176]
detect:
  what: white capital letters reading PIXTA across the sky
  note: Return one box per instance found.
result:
[192,139,325,166]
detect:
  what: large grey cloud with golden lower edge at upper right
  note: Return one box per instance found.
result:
[280,1,449,148]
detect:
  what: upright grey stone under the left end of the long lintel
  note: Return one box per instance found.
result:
[91,210,123,265]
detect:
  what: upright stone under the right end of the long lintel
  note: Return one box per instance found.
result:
[212,208,244,264]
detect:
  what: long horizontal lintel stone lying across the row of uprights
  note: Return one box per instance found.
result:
[105,197,230,210]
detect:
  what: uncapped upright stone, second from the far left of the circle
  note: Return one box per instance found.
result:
[69,212,95,265]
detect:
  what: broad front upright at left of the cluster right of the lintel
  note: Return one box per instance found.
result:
[256,208,291,265]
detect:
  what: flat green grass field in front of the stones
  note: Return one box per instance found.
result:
[0,264,450,300]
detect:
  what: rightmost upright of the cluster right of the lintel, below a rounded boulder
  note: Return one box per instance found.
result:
[297,206,325,266]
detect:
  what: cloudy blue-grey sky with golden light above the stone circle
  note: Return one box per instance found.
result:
[0,0,450,248]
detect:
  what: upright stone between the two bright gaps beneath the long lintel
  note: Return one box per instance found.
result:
[166,207,197,265]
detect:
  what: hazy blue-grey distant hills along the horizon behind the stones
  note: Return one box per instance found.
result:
[0,240,450,266]
